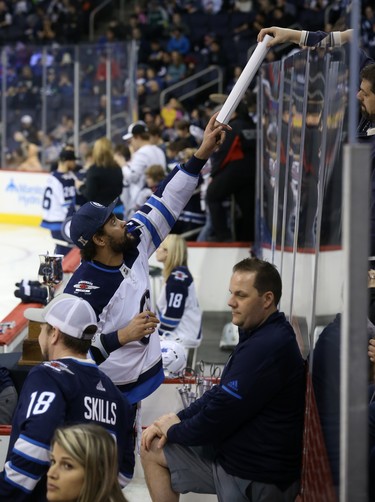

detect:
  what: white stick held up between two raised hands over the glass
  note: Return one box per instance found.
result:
[216,35,272,124]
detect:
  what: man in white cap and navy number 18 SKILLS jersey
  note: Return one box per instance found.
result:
[0,294,134,502]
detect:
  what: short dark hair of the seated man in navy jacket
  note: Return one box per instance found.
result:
[233,258,282,305]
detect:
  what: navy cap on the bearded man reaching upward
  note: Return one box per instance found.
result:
[70,199,118,249]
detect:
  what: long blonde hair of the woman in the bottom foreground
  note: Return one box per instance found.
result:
[52,423,126,502]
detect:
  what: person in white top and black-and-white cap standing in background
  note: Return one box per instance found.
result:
[123,121,166,219]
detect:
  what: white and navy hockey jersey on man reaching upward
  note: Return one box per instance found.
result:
[64,157,204,403]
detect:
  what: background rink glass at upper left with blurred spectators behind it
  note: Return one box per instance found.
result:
[0,42,137,170]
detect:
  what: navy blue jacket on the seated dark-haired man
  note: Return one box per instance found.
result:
[168,312,305,487]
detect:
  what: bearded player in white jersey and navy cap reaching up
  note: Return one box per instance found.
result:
[65,115,230,403]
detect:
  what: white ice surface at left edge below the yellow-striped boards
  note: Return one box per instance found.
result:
[0,223,54,321]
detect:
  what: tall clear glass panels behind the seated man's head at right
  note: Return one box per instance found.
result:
[256,42,348,494]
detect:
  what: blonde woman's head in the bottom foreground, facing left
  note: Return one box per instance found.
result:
[47,424,126,502]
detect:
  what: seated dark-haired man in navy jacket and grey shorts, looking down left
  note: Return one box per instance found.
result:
[141,258,305,502]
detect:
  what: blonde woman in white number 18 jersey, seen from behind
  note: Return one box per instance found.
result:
[156,234,202,348]
